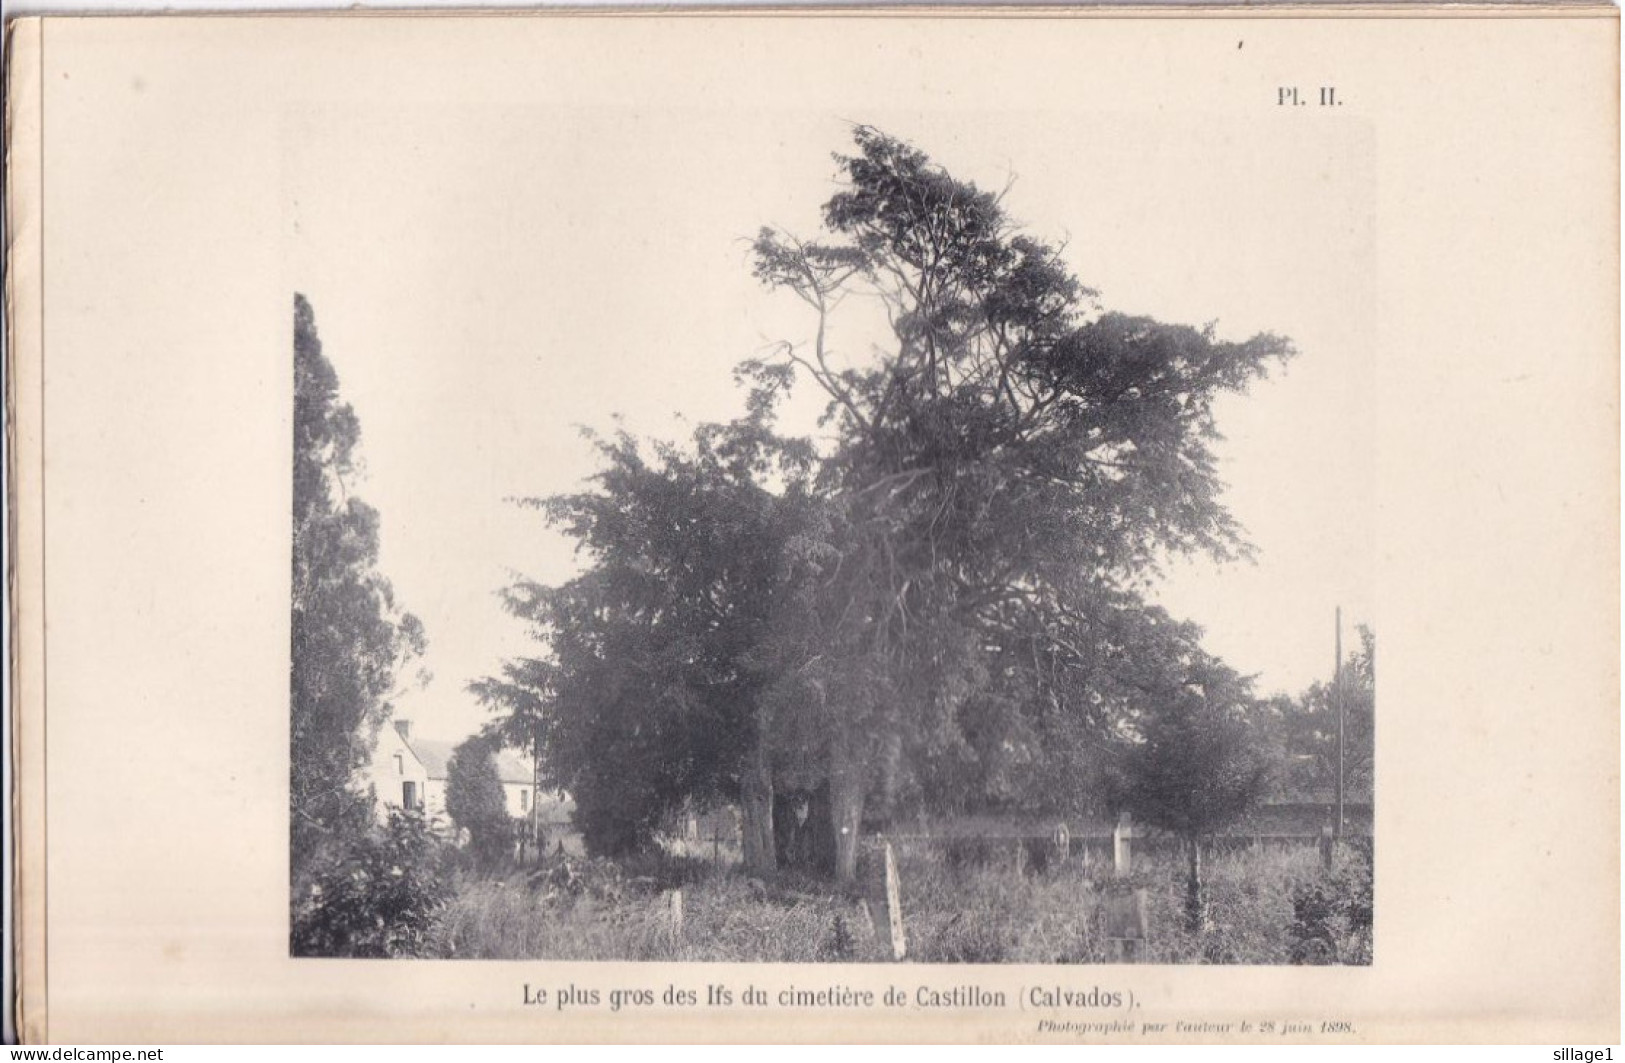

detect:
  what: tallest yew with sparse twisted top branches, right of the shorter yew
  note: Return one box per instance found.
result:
[756,127,1292,878]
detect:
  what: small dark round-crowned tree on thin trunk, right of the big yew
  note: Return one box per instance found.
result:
[1118,650,1276,931]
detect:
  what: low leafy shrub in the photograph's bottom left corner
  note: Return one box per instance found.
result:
[291,808,449,957]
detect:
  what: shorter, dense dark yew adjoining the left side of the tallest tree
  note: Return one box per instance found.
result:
[473,404,814,866]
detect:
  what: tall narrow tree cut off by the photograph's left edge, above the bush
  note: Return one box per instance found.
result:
[289,296,424,897]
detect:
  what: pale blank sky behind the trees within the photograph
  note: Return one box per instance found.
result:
[283,101,1378,740]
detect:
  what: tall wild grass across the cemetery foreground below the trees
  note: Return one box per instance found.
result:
[431,842,1370,964]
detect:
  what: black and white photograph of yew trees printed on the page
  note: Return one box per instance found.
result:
[288,112,1376,965]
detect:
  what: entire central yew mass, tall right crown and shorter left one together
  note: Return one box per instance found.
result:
[481,127,1292,879]
